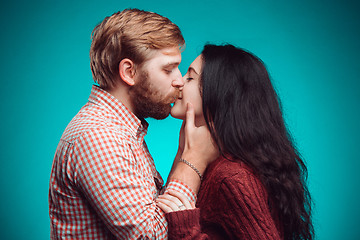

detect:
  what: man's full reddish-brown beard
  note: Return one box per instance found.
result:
[129,71,177,120]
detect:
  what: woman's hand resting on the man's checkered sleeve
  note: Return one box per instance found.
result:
[156,190,195,213]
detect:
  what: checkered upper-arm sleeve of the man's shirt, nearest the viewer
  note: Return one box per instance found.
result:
[74,129,167,239]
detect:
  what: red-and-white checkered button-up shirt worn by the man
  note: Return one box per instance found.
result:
[49,86,195,239]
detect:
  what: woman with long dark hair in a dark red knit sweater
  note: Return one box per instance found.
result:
[157,45,313,239]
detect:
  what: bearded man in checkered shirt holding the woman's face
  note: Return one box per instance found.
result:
[49,9,216,239]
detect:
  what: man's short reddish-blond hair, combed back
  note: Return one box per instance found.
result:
[90,9,185,88]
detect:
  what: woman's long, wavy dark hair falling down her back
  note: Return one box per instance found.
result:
[201,45,313,239]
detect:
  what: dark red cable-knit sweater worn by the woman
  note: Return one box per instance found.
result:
[166,157,281,240]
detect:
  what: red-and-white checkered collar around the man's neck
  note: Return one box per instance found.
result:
[89,85,149,138]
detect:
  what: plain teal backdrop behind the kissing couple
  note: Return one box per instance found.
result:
[0,0,360,240]
